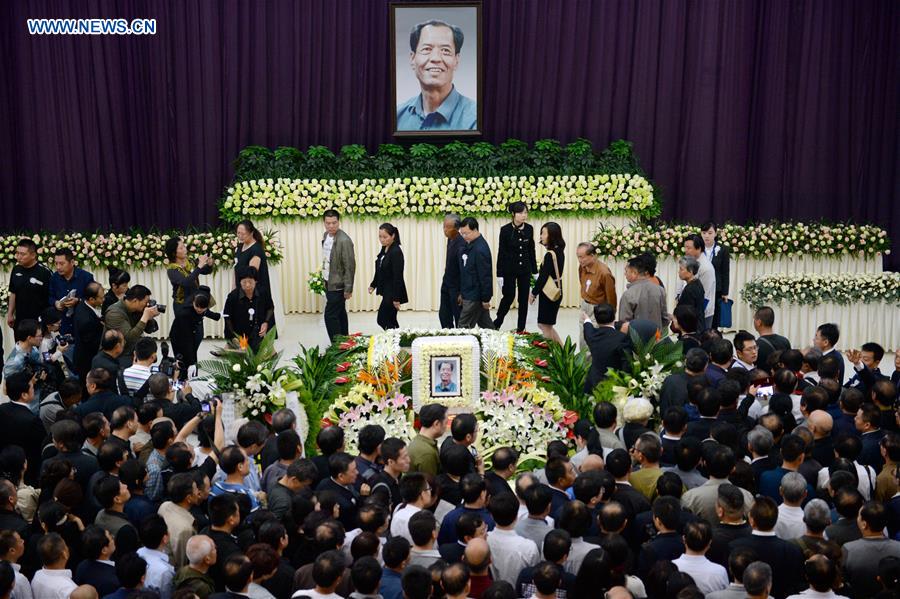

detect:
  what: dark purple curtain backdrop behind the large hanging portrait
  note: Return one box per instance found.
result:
[0,0,900,266]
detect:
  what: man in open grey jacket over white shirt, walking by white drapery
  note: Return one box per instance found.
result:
[322,210,356,343]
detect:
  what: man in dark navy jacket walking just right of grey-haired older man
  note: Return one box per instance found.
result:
[459,216,494,329]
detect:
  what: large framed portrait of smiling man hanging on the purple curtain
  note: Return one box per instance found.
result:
[390,2,482,137]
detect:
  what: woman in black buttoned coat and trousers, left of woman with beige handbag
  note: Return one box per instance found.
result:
[494,202,537,331]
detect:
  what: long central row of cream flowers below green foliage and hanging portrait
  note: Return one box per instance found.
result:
[220,174,659,222]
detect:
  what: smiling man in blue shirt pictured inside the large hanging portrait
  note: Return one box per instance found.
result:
[397,20,478,131]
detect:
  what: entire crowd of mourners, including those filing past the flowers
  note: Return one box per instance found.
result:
[0,212,900,599]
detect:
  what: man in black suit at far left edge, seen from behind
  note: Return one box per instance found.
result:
[0,368,47,485]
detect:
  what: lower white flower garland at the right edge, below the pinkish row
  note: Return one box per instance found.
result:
[741,272,900,308]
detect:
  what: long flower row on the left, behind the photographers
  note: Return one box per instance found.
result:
[0,229,284,270]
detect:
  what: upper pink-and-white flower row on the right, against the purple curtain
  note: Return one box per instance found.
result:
[594,222,891,259]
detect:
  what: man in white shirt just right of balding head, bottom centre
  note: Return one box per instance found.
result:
[487,493,541,584]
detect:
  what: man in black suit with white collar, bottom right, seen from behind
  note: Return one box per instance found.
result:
[728,496,806,599]
